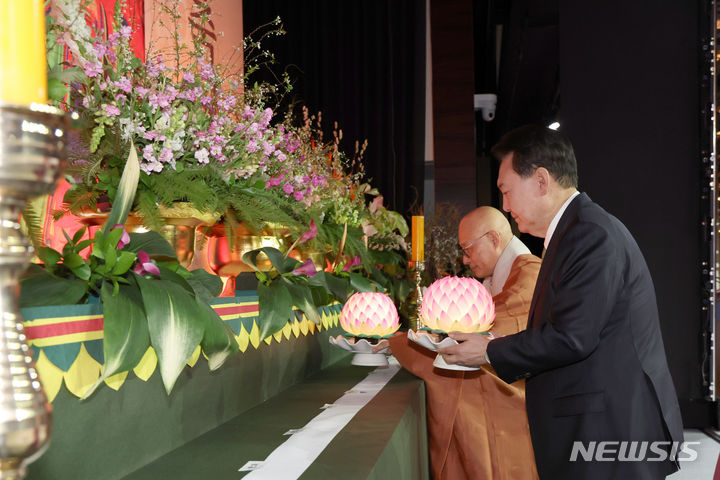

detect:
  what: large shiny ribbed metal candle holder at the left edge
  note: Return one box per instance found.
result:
[0,104,69,480]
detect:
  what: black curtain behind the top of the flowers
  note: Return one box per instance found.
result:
[243,0,426,214]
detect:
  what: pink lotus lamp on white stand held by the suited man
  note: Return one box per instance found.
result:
[408,277,495,370]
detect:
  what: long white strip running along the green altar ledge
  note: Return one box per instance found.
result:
[240,357,400,480]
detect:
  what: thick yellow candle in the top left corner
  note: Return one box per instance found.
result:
[0,0,47,105]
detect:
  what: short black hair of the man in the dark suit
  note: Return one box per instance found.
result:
[491,125,578,188]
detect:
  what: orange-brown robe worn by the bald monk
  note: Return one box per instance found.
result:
[390,255,540,480]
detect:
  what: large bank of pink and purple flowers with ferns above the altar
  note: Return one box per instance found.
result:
[35,0,410,352]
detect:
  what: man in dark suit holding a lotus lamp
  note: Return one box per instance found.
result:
[440,125,682,480]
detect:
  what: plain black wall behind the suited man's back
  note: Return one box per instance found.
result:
[559,0,703,424]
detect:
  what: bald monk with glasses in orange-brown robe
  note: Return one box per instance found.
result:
[389,207,540,480]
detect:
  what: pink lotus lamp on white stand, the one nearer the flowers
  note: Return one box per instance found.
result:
[330,292,400,366]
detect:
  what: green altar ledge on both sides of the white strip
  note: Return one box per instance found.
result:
[124,361,429,480]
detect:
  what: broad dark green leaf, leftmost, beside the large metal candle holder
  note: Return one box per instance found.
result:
[19,273,87,308]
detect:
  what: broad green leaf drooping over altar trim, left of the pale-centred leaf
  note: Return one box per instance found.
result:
[83,282,150,398]
